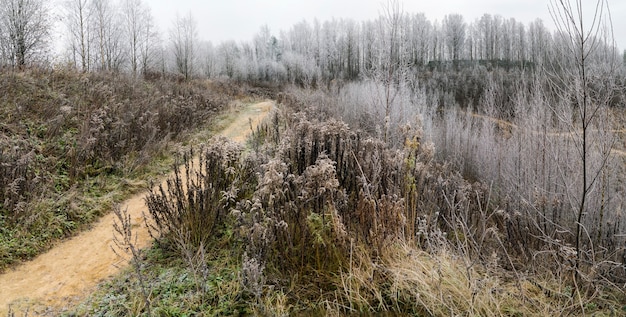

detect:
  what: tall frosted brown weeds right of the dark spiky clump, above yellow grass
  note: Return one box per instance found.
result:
[237,106,497,286]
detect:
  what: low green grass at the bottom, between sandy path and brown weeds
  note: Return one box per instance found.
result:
[65,241,253,316]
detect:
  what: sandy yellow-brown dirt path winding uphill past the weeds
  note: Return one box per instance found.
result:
[0,102,274,317]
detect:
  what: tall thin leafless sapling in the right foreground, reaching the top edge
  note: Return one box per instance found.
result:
[548,0,618,276]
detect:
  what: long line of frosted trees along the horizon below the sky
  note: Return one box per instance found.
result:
[0,0,619,85]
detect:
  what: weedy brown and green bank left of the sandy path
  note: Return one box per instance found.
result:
[0,69,260,272]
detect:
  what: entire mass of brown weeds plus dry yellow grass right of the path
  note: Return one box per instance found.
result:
[116,94,620,316]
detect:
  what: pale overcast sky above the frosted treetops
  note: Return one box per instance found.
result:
[145,0,626,48]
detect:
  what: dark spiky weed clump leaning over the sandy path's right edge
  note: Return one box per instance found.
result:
[146,138,256,248]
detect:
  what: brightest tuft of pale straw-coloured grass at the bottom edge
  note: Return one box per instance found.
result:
[378,244,554,316]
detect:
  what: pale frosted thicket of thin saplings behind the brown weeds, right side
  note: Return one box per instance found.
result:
[281,77,626,285]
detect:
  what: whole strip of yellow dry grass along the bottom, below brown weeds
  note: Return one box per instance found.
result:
[327,242,616,316]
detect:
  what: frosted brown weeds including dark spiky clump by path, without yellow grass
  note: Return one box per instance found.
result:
[147,106,497,306]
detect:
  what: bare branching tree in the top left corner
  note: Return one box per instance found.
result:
[0,0,51,68]
